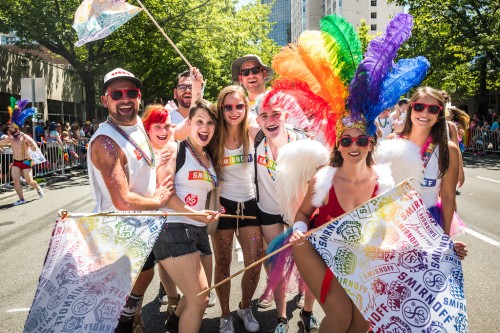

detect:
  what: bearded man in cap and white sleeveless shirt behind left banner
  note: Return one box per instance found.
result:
[88,68,174,332]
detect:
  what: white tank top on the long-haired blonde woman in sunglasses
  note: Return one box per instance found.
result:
[221,143,255,202]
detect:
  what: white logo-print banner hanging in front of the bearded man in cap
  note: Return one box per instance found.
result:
[24,212,165,333]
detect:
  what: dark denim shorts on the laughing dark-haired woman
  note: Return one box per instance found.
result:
[153,223,212,260]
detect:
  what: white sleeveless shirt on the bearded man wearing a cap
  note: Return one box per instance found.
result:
[87,117,156,212]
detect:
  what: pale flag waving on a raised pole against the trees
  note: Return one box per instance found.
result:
[73,0,142,47]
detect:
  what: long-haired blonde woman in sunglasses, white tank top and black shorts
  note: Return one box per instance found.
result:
[212,86,262,332]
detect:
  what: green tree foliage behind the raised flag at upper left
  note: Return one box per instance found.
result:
[0,0,278,115]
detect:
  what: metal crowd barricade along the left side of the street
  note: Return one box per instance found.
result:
[0,139,88,192]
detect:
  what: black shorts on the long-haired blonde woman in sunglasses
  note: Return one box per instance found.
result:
[217,197,260,230]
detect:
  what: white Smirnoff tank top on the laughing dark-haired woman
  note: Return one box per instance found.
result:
[167,147,215,227]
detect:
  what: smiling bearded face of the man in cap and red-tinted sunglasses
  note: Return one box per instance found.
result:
[101,80,141,126]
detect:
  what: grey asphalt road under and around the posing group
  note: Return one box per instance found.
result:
[0,155,500,333]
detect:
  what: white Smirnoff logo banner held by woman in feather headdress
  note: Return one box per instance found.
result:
[309,182,468,333]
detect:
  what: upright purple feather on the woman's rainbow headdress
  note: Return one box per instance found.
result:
[349,13,413,120]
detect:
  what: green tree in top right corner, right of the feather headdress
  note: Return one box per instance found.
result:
[393,0,500,115]
